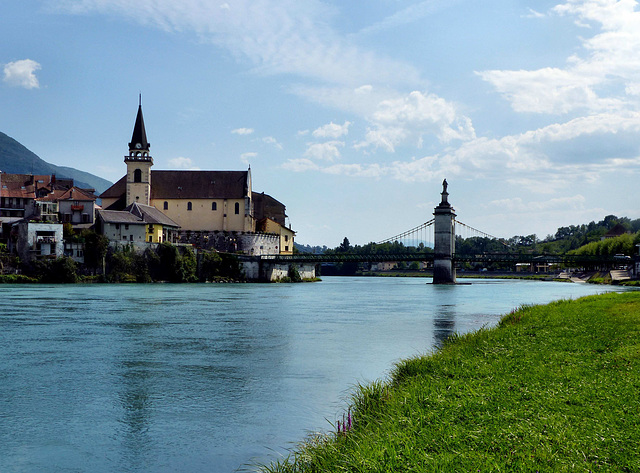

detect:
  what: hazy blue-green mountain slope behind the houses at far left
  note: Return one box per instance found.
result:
[0,132,112,195]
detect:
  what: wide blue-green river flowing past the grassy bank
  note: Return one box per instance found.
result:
[0,277,623,473]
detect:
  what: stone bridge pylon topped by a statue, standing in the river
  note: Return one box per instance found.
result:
[433,179,456,284]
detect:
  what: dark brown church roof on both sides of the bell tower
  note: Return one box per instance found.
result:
[100,171,249,200]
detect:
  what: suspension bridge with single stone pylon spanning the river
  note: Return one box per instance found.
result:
[261,180,632,283]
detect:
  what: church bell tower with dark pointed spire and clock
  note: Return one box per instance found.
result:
[124,94,153,207]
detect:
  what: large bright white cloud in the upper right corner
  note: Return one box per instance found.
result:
[478,0,640,114]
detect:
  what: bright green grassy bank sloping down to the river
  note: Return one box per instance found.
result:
[265,292,640,472]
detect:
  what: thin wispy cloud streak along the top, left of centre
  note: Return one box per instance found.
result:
[50,0,420,84]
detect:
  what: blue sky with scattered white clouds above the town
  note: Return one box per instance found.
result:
[0,0,640,247]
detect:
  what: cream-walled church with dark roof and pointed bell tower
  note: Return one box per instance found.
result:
[100,102,295,254]
